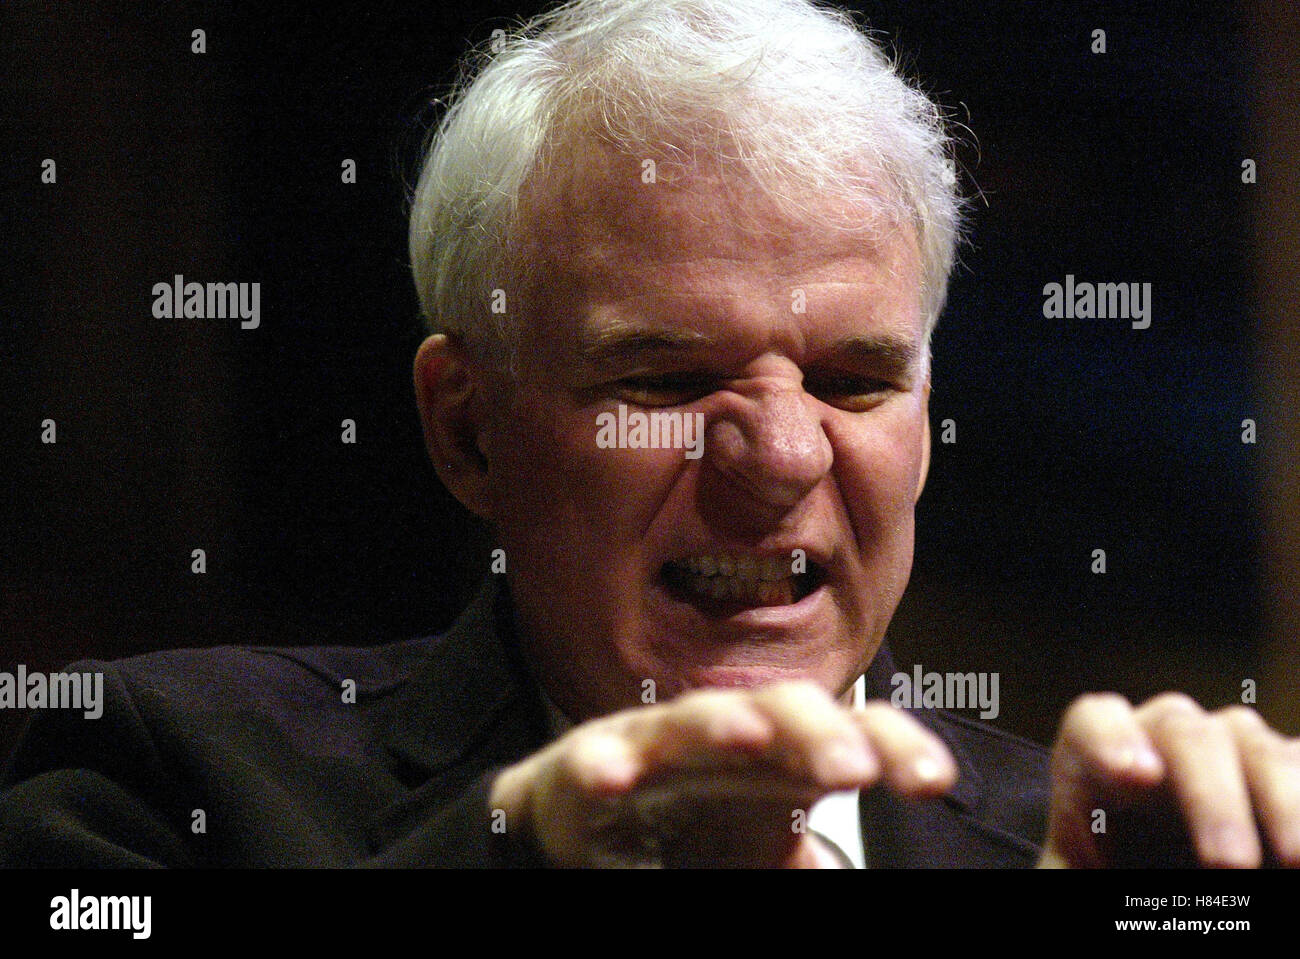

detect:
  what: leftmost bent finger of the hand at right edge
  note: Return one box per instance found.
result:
[1043,693,1165,868]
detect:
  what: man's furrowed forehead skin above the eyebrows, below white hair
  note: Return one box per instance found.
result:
[516,144,920,348]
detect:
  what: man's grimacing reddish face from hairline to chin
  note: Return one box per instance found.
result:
[473,151,930,721]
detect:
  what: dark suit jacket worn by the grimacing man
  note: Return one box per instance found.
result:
[0,581,1047,867]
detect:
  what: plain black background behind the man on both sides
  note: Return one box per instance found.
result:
[0,0,1300,747]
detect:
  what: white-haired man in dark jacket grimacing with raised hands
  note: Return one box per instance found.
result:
[0,0,1300,867]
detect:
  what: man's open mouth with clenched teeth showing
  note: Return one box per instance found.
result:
[660,554,826,612]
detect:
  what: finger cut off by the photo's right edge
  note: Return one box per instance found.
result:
[1218,706,1300,868]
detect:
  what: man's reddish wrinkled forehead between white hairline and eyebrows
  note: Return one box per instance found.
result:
[501,142,920,319]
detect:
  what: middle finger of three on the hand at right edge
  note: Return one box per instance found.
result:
[1136,693,1262,868]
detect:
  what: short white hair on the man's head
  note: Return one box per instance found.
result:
[410,0,961,366]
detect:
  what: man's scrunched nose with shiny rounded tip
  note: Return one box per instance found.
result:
[703,383,832,512]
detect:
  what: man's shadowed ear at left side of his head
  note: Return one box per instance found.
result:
[415,333,491,520]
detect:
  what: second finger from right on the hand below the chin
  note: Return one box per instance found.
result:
[754,682,880,790]
